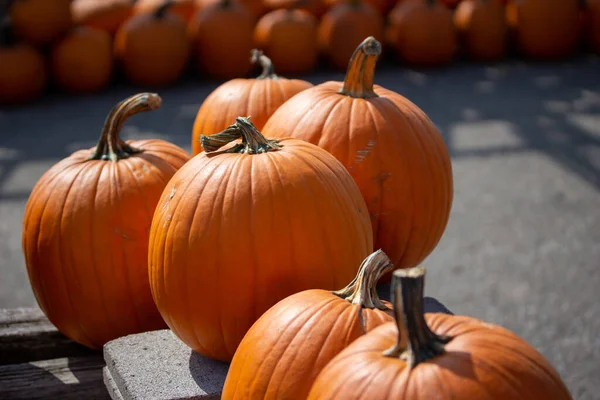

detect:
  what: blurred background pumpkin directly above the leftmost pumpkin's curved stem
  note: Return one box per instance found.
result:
[114,1,191,87]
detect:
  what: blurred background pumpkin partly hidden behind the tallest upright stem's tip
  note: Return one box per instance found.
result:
[319,0,384,70]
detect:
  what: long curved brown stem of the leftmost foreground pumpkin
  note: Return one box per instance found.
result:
[88,93,162,162]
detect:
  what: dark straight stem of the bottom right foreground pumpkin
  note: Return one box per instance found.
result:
[384,267,451,368]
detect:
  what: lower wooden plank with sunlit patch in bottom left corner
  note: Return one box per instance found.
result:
[0,355,110,400]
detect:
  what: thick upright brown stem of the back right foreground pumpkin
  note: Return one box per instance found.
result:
[339,36,381,99]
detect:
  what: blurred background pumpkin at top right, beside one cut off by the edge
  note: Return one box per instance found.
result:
[506,0,580,60]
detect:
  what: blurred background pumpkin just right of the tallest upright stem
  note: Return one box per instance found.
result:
[386,0,458,67]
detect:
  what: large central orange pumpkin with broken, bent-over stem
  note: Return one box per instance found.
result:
[149,117,373,361]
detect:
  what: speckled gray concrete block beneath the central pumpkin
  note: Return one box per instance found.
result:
[103,329,229,400]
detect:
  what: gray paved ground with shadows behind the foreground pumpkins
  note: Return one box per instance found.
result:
[0,57,600,400]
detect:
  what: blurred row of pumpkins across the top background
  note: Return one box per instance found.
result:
[0,0,600,104]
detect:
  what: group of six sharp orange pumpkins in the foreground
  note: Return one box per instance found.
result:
[22,37,571,400]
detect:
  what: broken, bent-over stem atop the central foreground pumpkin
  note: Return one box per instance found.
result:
[200,117,281,154]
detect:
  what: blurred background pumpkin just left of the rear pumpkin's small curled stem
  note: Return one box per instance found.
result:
[188,0,256,79]
